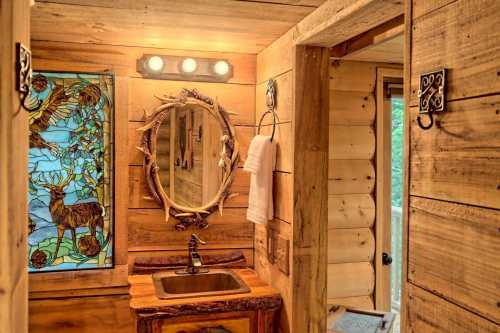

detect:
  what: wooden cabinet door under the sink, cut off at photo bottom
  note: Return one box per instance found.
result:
[161,318,251,333]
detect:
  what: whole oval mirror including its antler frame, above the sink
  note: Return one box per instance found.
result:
[138,89,239,230]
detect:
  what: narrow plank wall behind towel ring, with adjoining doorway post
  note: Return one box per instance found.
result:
[255,31,329,333]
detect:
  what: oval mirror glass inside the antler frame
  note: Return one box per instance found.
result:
[156,105,223,207]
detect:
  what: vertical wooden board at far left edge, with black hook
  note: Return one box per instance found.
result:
[0,0,30,333]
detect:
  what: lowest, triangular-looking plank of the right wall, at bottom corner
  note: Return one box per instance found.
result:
[405,283,500,333]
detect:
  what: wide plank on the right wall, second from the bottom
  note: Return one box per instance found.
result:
[408,197,500,323]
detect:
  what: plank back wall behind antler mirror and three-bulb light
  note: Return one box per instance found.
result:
[30,40,256,333]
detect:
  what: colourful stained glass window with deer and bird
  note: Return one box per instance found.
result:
[28,72,114,272]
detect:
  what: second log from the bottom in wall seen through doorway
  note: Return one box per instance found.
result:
[328,228,375,264]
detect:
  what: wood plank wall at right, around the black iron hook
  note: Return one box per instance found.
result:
[405,0,500,333]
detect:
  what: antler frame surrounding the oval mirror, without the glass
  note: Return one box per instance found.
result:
[137,89,240,230]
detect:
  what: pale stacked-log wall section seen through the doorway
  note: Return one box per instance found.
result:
[328,61,377,309]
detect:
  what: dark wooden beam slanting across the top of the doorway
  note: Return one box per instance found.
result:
[330,15,404,58]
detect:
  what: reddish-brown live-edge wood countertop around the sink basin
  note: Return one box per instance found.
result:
[129,269,281,319]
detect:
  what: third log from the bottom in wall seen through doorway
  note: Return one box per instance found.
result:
[328,194,375,228]
